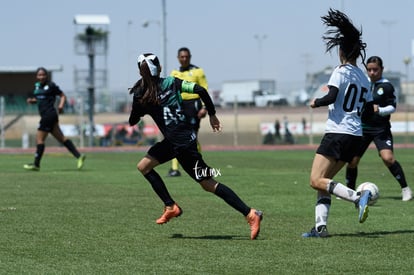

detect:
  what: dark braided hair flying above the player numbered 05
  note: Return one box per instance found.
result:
[321,9,367,67]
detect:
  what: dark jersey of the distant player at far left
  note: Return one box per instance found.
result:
[33,81,63,116]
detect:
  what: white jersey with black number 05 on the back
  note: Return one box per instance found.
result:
[325,64,372,136]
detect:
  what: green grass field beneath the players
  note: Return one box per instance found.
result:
[0,149,414,274]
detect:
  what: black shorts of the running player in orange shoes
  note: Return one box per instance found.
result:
[147,139,215,182]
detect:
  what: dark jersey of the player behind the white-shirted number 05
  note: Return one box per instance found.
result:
[362,78,397,132]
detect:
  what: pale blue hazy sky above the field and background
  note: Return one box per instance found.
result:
[0,0,414,92]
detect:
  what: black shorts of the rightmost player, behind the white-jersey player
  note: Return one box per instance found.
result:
[356,128,394,157]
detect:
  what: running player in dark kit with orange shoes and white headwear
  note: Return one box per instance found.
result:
[129,53,262,240]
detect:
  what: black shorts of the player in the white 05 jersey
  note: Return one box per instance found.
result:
[316,133,361,162]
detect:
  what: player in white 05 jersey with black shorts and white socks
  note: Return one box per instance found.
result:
[302,9,372,238]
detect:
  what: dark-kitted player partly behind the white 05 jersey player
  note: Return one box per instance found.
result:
[346,56,413,201]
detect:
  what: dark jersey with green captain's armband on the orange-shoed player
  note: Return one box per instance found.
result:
[129,77,215,150]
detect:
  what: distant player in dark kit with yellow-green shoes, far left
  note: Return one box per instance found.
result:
[23,67,85,171]
